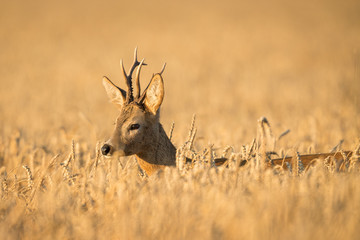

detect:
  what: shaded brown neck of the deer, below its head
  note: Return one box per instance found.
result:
[136,123,176,176]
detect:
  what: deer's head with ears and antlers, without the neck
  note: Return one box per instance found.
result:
[101,49,165,156]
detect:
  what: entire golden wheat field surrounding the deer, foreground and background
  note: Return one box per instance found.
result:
[0,0,360,239]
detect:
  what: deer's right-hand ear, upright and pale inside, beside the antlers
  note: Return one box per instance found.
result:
[144,74,164,115]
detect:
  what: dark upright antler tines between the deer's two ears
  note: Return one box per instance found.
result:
[120,47,146,103]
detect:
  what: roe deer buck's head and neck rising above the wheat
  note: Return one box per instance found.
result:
[101,49,176,175]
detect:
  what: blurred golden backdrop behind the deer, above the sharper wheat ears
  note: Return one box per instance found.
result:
[0,0,360,151]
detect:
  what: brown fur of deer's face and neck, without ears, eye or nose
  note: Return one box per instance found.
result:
[110,103,176,175]
